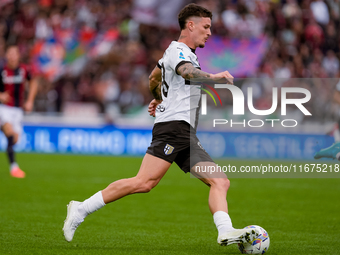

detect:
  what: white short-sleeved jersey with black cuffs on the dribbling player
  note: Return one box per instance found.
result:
[155,41,201,129]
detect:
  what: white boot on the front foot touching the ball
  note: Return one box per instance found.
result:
[217,228,259,246]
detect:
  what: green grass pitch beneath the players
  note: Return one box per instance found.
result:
[0,153,340,255]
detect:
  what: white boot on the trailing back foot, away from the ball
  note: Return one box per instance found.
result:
[63,201,84,242]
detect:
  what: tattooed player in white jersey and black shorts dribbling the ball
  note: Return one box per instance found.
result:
[63,4,258,245]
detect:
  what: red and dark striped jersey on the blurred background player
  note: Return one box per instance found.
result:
[0,64,31,107]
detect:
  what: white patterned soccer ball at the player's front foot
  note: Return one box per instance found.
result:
[238,225,270,254]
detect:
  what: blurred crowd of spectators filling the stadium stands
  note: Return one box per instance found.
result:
[0,0,340,119]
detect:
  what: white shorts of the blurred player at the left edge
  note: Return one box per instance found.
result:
[0,104,24,136]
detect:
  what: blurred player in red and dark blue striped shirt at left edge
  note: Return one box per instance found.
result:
[0,45,38,178]
